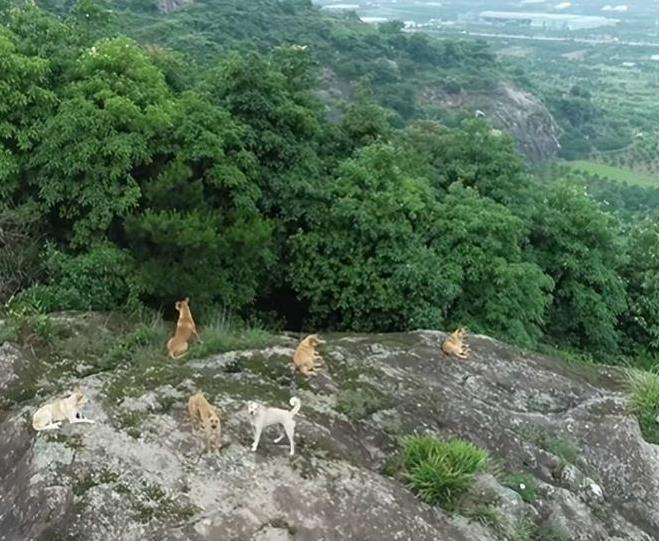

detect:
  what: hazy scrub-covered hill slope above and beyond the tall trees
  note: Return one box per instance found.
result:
[32,0,503,119]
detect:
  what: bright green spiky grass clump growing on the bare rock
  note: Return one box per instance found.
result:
[403,435,489,509]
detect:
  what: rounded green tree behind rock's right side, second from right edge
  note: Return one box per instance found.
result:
[531,179,626,355]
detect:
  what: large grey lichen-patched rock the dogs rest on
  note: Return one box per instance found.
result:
[0,322,659,541]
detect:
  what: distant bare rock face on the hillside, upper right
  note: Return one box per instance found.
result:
[421,83,561,162]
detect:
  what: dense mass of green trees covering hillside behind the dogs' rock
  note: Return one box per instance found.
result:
[0,0,659,365]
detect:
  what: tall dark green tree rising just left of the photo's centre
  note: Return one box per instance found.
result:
[205,48,324,220]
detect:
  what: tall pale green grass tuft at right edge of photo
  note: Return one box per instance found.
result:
[627,369,659,444]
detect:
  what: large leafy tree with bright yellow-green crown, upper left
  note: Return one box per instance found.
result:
[31,38,171,246]
